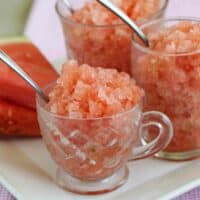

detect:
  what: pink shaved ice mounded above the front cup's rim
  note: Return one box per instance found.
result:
[48,60,144,118]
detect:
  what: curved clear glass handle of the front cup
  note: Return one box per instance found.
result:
[129,111,173,161]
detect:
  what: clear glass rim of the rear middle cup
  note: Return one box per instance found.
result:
[55,0,169,29]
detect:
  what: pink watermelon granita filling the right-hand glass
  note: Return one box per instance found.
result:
[132,19,200,158]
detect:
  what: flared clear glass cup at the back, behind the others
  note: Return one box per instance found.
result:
[56,0,168,73]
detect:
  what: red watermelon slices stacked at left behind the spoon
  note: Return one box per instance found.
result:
[0,36,58,137]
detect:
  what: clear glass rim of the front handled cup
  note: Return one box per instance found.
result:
[36,81,145,121]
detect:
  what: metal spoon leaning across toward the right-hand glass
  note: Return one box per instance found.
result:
[97,0,149,46]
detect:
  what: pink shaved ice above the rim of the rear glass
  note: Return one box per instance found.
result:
[71,0,160,25]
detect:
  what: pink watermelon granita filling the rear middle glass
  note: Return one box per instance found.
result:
[57,0,167,72]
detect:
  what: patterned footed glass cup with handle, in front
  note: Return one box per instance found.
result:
[37,84,173,194]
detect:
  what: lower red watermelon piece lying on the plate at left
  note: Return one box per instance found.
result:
[0,99,40,137]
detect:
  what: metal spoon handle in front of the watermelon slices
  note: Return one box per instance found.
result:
[0,50,49,102]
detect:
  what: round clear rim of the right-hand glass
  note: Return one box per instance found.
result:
[132,16,200,57]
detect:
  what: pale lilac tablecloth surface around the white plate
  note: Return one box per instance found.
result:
[0,0,200,200]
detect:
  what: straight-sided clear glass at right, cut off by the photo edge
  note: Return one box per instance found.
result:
[132,18,200,160]
